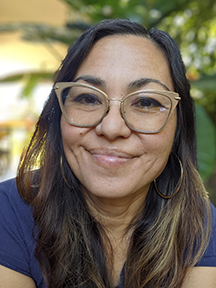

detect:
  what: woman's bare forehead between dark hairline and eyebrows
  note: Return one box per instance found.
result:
[75,35,173,90]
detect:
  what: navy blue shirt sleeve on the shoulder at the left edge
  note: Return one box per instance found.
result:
[0,179,34,264]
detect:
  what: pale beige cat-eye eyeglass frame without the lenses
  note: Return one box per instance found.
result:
[53,82,181,134]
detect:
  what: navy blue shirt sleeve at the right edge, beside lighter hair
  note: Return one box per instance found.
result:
[196,204,216,267]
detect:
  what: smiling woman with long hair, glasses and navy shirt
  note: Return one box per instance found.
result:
[0,20,216,288]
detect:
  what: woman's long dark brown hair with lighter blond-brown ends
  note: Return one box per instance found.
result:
[17,20,210,288]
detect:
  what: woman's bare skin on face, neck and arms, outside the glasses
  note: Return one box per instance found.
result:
[0,35,216,288]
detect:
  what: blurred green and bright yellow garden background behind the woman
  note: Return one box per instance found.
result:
[0,0,216,204]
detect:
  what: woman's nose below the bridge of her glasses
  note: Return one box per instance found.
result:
[95,98,132,141]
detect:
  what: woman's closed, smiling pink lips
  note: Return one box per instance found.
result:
[87,148,134,167]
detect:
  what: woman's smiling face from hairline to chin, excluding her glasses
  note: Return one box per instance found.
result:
[61,35,176,201]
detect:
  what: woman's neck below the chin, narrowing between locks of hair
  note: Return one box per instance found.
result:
[83,189,148,287]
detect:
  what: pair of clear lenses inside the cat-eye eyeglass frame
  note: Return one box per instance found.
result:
[62,86,172,132]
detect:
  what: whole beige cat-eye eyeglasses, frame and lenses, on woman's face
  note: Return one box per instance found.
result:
[54,82,181,134]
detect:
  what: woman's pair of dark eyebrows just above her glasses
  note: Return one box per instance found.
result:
[73,75,170,91]
